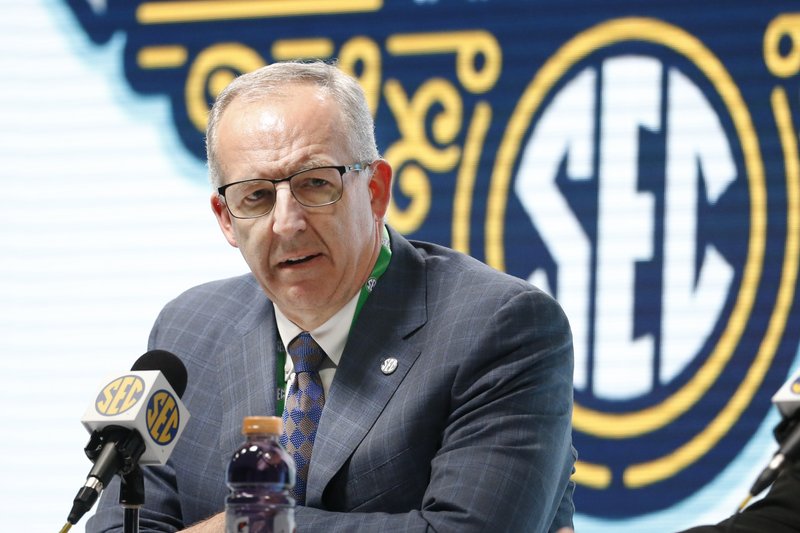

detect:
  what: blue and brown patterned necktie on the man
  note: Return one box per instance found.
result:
[280,331,325,505]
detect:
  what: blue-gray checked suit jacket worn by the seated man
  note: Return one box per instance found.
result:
[87,232,575,533]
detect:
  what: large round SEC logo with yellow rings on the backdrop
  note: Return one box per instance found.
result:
[486,18,788,517]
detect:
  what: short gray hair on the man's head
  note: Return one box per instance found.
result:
[206,61,380,188]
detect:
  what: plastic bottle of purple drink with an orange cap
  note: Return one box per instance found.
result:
[225,416,295,533]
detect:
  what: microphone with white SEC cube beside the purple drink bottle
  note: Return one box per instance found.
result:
[67,350,189,525]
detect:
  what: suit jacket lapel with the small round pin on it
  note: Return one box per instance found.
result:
[306,233,427,507]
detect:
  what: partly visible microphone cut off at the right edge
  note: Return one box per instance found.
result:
[740,369,800,509]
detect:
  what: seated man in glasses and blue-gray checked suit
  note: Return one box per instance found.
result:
[88,62,575,533]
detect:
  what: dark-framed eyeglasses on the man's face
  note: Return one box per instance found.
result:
[217,163,369,218]
